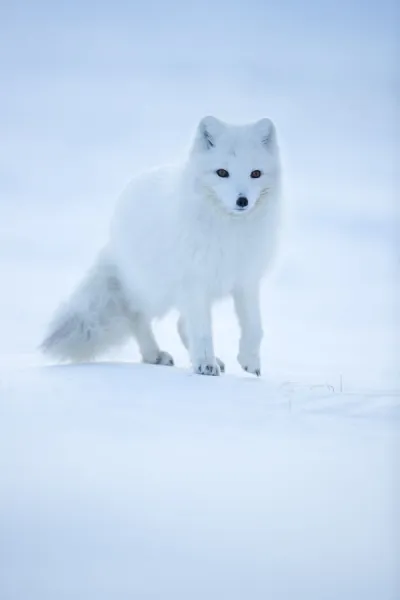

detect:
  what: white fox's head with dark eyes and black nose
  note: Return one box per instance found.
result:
[191,117,279,216]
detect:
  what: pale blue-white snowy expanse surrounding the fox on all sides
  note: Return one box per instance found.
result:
[0,0,400,600]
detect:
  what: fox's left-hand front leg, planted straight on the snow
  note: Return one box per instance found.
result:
[181,291,220,375]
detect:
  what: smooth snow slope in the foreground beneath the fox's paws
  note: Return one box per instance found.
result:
[0,363,399,599]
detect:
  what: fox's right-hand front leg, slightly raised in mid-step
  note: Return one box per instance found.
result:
[233,282,263,376]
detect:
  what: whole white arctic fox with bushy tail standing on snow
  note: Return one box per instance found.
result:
[41,116,280,375]
